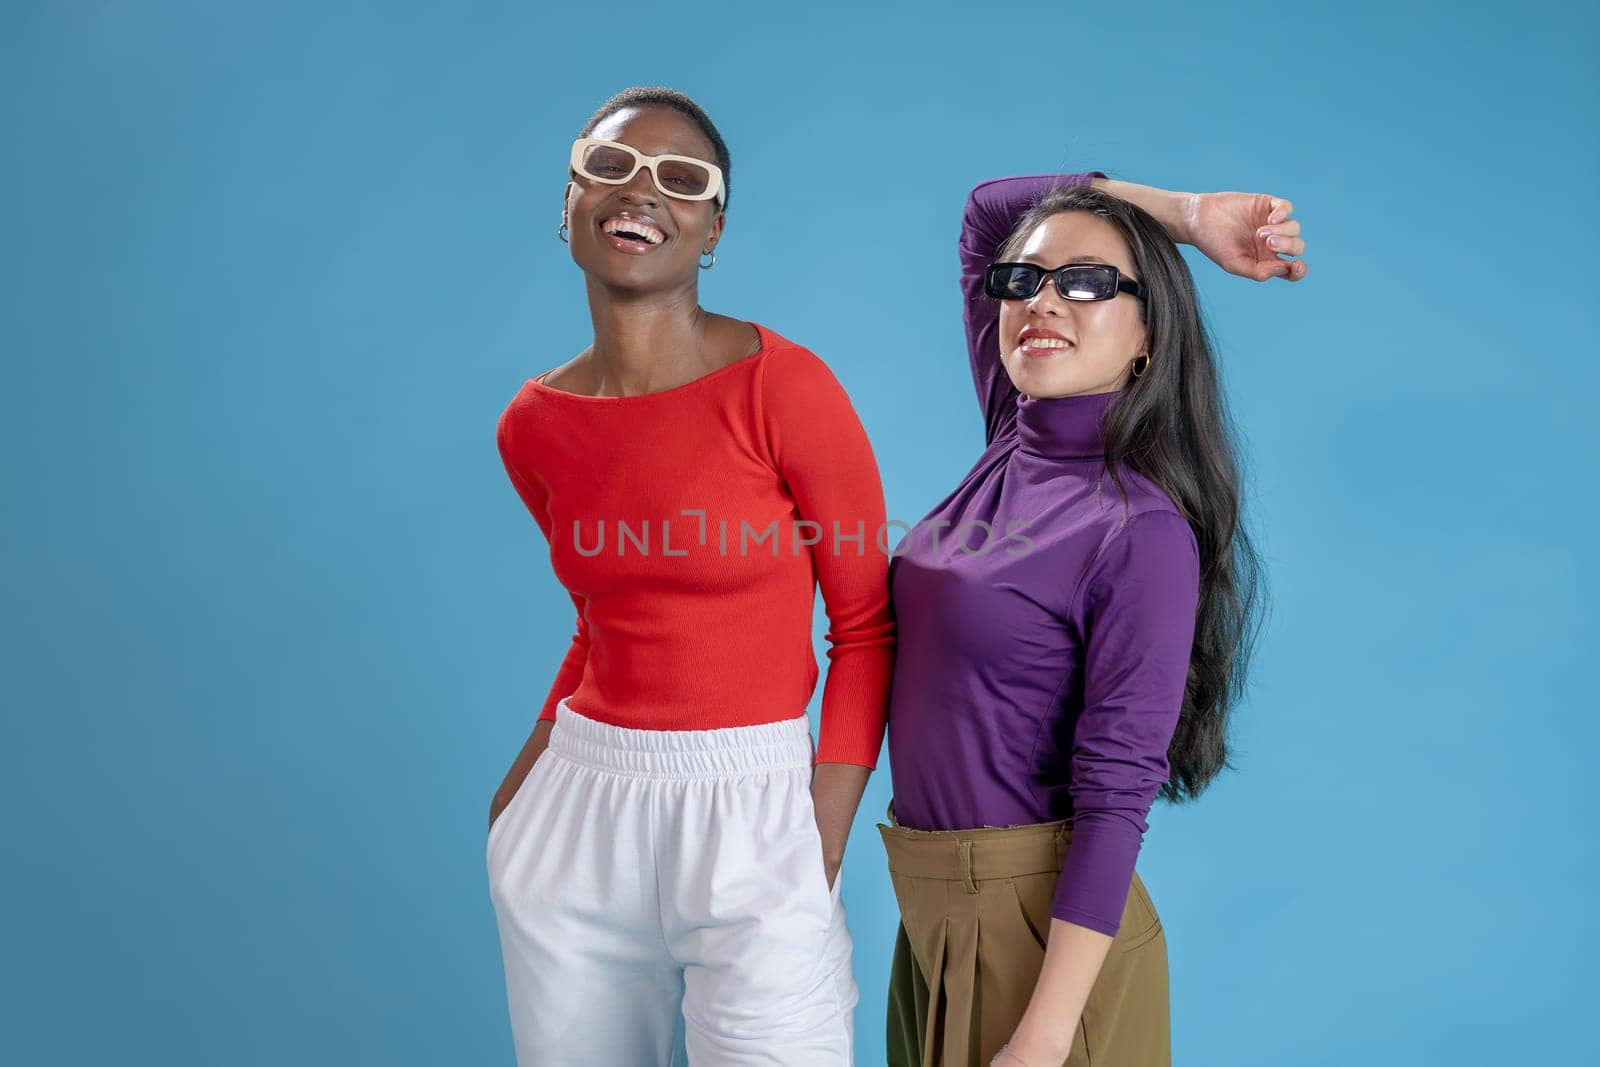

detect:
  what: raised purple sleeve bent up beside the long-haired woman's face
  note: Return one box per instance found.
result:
[960,173,1099,443]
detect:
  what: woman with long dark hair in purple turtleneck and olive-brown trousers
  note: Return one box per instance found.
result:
[880,174,1306,1067]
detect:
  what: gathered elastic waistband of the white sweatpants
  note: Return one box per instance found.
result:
[550,701,814,779]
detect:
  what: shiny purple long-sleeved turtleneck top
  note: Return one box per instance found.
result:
[888,174,1200,936]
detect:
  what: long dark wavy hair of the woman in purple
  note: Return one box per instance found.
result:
[1000,187,1266,801]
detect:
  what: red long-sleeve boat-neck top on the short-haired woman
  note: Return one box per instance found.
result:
[498,323,894,768]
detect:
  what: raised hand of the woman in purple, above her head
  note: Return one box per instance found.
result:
[1182,192,1309,282]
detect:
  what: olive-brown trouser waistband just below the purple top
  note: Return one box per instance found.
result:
[878,801,1072,886]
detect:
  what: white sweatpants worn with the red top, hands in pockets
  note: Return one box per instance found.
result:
[488,702,858,1067]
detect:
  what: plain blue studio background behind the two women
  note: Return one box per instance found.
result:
[0,0,1600,1067]
